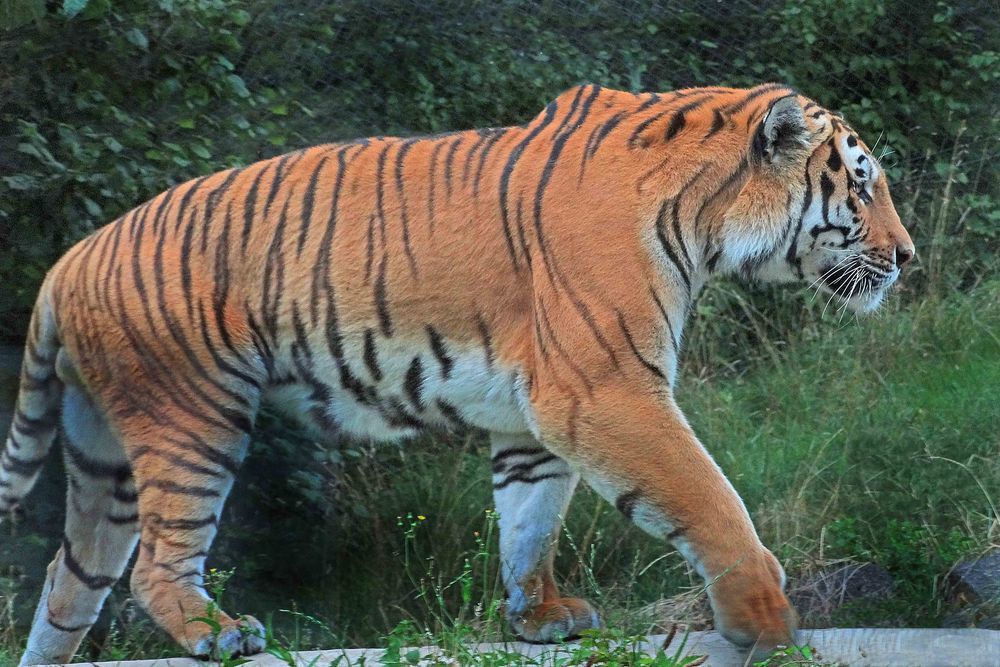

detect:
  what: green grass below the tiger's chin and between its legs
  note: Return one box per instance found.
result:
[0,282,1000,665]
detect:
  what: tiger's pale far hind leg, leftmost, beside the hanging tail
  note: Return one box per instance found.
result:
[21,385,139,665]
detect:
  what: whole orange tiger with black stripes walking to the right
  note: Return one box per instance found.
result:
[0,83,915,665]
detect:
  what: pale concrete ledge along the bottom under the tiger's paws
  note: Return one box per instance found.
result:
[45,628,1000,667]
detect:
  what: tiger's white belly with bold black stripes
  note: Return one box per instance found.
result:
[264,340,529,441]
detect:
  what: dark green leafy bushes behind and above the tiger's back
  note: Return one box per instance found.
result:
[0,0,1000,339]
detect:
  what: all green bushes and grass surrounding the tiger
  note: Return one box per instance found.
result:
[0,0,1000,665]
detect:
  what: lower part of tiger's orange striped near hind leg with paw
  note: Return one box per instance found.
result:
[125,415,265,657]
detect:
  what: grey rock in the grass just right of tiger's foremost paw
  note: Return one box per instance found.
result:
[788,563,893,625]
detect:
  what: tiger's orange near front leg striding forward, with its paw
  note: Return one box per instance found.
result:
[533,382,797,651]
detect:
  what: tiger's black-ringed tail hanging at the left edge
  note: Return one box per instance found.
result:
[0,286,63,512]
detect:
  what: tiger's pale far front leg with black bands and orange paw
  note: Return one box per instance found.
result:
[491,434,600,642]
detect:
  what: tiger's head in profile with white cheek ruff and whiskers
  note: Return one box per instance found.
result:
[723,94,914,313]
